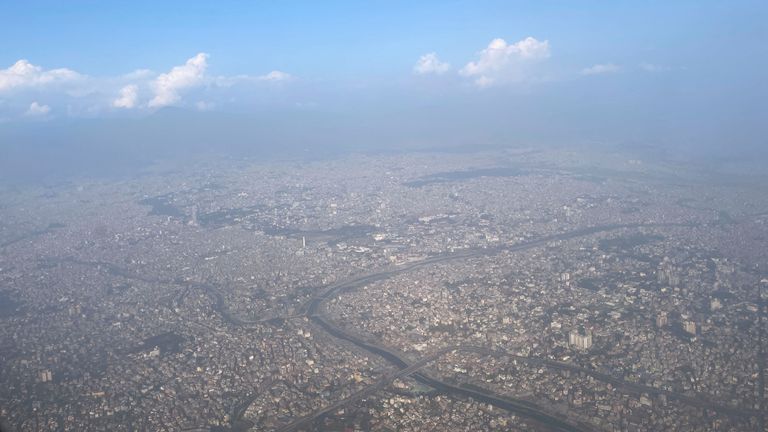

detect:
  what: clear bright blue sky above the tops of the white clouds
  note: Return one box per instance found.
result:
[0,0,765,79]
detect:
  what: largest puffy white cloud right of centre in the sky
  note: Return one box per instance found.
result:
[459,36,550,87]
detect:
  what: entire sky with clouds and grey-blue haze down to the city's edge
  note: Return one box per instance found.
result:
[0,1,768,180]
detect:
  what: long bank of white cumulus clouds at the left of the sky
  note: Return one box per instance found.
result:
[0,53,295,118]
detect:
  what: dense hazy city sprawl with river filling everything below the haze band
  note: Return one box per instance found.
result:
[0,148,768,431]
